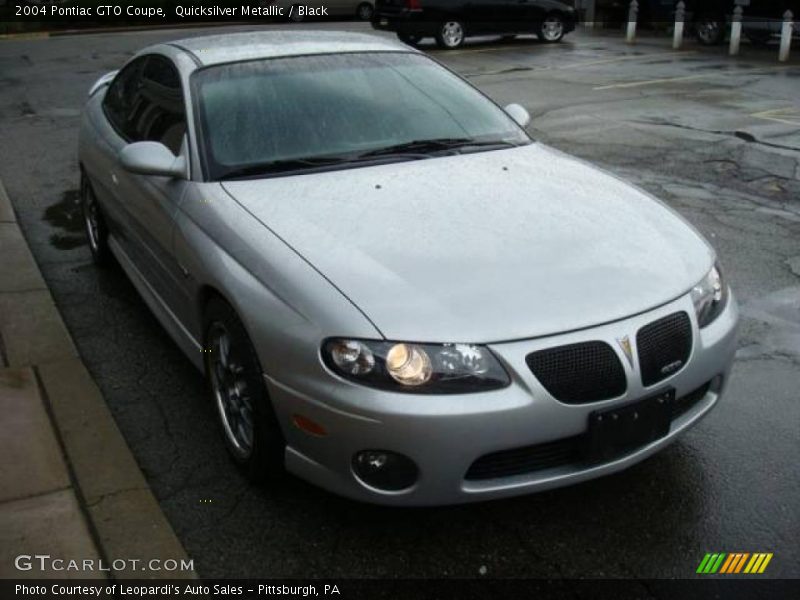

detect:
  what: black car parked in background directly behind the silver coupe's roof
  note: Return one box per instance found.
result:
[372,0,578,48]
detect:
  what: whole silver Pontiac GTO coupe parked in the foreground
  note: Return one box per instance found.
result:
[80,31,738,505]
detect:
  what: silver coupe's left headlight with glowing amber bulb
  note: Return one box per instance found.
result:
[322,338,510,394]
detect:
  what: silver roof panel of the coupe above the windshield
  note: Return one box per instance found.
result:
[164,30,414,66]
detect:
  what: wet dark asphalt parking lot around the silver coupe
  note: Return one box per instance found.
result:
[0,25,800,578]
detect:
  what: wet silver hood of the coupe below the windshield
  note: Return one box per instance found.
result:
[222,144,714,343]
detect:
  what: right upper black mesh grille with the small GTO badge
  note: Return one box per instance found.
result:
[636,312,692,386]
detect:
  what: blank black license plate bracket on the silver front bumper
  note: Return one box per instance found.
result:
[587,389,675,462]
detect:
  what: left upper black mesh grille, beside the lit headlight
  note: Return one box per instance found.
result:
[525,342,627,404]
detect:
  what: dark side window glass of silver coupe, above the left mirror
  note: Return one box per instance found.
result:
[104,55,186,154]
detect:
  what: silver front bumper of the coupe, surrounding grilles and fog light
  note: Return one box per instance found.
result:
[265,295,738,506]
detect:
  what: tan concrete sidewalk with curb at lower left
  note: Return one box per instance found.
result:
[0,181,196,579]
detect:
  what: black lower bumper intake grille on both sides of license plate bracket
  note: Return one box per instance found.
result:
[464,381,711,481]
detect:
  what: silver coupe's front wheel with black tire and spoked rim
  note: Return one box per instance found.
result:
[203,297,286,482]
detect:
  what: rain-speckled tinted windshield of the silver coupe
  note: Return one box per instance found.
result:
[193,52,530,180]
